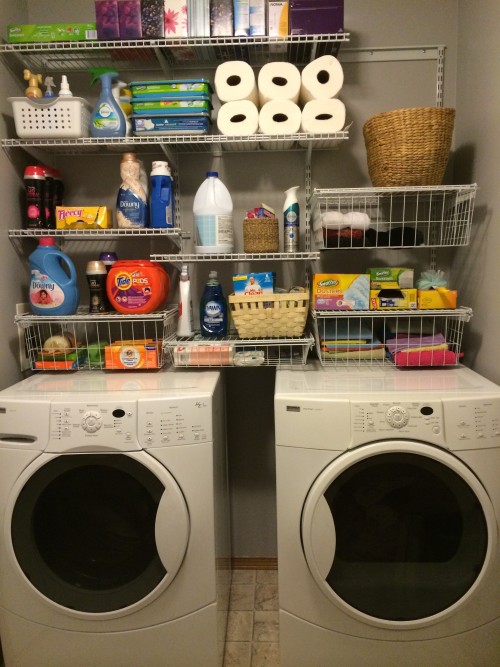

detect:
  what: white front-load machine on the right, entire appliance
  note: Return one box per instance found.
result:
[275,367,500,667]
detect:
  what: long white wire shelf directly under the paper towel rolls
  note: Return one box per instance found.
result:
[1,130,349,155]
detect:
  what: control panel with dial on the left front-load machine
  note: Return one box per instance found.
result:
[46,396,212,452]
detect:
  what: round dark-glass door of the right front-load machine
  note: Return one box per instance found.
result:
[301,441,496,627]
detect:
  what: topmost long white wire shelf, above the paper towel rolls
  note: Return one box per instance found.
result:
[0,33,349,75]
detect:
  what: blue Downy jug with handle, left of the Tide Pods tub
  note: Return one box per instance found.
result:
[29,237,80,315]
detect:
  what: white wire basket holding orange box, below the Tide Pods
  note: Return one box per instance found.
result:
[15,306,178,371]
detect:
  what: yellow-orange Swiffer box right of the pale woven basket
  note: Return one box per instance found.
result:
[312,273,370,310]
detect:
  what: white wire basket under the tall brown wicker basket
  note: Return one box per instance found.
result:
[310,183,477,250]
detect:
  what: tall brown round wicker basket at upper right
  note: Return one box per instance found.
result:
[363,107,455,187]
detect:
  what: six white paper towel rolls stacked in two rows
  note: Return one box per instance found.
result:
[214,56,345,148]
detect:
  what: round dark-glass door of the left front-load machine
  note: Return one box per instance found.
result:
[11,453,189,613]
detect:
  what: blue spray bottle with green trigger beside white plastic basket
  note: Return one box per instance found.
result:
[90,67,127,137]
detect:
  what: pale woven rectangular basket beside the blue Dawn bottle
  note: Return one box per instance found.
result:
[228,290,309,338]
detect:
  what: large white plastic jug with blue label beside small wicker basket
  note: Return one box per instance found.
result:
[193,171,234,254]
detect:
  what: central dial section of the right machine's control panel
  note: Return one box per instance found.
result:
[351,401,445,447]
